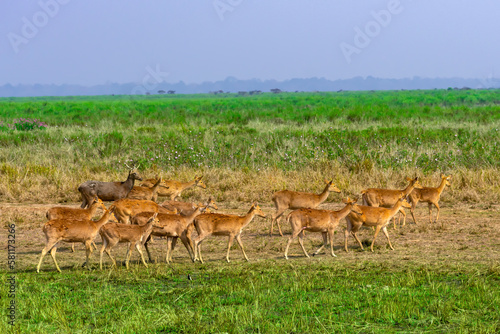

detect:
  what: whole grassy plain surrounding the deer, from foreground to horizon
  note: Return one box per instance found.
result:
[0,90,500,333]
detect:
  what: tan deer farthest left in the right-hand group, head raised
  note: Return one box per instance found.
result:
[269,180,340,236]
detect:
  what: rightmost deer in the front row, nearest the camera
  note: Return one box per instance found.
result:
[344,195,410,252]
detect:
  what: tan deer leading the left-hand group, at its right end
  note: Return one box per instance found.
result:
[193,203,266,263]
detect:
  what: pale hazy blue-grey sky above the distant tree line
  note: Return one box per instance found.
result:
[0,0,500,85]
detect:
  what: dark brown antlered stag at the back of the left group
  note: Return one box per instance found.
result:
[78,169,142,209]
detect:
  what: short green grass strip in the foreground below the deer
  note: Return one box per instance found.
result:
[2,261,500,333]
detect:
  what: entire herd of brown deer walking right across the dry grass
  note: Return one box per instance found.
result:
[37,170,451,272]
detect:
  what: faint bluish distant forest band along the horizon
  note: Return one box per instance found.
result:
[0,76,500,97]
